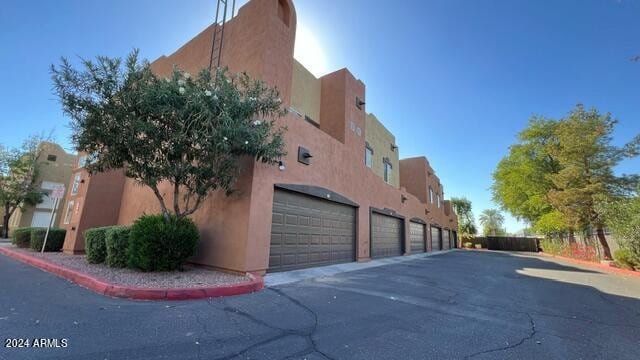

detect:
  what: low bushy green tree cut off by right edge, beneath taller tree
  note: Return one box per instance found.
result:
[596,193,640,264]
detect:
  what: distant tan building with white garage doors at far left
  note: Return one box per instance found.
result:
[9,142,77,235]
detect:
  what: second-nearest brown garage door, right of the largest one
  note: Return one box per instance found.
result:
[371,213,402,258]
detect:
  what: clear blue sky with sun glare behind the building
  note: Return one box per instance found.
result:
[0,0,640,231]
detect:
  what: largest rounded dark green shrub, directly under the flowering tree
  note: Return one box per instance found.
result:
[128,215,200,271]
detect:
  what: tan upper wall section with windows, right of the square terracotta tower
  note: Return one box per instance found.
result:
[362,114,400,188]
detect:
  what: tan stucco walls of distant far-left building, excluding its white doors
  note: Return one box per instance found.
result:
[9,142,77,232]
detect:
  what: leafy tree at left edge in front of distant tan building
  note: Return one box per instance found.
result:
[0,136,44,237]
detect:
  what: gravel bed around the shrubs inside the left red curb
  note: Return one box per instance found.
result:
[5,246,250,289]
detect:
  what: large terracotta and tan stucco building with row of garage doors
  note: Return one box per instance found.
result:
[63,0,457,273]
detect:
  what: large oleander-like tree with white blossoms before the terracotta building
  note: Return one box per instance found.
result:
[51,50,285,221]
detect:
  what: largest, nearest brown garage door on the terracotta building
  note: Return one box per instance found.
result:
[268,189,356,272]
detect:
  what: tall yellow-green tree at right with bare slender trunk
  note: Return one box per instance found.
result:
[548,105,640,259]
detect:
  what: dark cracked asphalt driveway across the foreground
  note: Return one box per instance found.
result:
[0,251,640,360]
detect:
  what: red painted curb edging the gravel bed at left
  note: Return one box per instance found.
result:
[0,247,264,300]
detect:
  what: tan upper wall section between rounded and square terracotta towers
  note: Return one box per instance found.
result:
[291,59,322,124]
